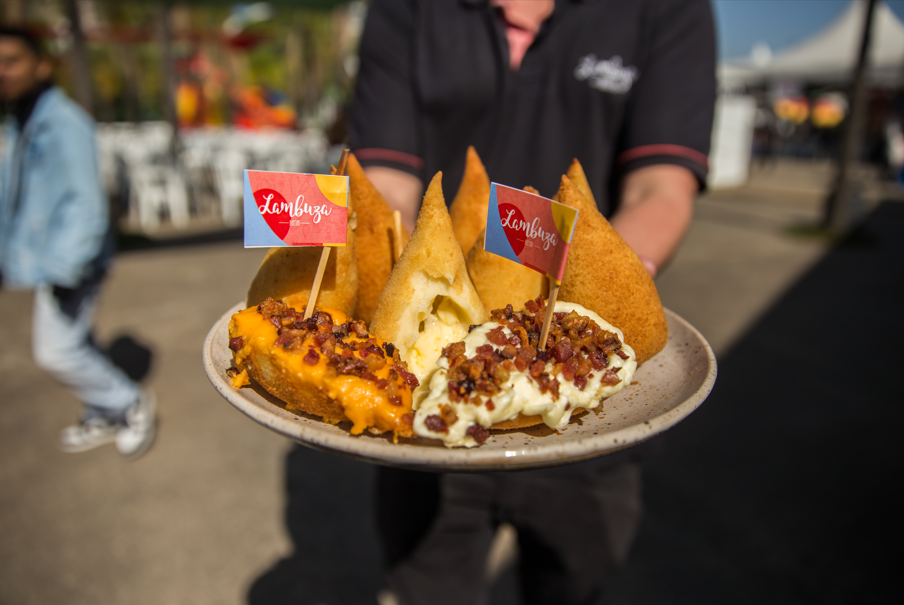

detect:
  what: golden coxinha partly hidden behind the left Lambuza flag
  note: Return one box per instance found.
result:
[247,219,358,316]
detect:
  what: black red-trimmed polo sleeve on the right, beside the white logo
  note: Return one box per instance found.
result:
[616,0,716,190]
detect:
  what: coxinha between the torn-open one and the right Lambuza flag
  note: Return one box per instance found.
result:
[466,226,549,312]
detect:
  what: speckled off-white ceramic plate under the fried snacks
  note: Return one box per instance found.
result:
[203,304,716,472]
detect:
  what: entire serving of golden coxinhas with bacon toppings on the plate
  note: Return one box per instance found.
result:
[230,151,668,446]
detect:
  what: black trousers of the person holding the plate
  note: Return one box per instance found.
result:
[377,459,643,605]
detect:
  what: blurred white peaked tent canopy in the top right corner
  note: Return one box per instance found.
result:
[719,0,904,88]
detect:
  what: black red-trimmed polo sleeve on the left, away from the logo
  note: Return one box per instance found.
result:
[349,0,424,180]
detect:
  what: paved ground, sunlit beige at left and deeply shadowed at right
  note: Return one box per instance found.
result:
[0,177,904,605]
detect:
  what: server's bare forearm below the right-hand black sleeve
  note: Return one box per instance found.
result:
[612,166,698,274]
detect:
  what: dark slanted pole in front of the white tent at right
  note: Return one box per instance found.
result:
[823,0,876,233]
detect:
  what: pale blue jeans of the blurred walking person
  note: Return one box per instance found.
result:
[32,277,140,420]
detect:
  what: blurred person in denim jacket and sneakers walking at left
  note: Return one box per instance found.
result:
[0,28,156,458]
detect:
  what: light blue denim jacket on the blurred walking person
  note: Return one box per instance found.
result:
[0,87,112,288]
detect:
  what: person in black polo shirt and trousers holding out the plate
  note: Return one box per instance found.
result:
[350,0,716,605]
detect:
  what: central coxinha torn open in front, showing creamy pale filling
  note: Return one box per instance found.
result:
[370,172,487,384]
